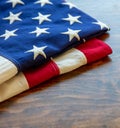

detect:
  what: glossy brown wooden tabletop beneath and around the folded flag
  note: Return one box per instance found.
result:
[0,0,120,128]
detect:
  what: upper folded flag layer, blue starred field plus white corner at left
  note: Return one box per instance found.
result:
[0,0,109,84]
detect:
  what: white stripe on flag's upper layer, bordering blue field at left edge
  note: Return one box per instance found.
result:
[0,56,18,84]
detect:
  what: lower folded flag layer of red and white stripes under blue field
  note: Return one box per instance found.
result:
[0,39,112,102]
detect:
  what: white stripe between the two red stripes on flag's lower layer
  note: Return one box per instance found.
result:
[53,48,87,74]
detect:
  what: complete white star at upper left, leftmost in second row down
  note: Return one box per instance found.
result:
[3,12,22,24]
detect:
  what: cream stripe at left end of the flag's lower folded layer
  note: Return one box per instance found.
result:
[0,73,29,102]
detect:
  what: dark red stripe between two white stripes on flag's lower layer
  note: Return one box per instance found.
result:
[24,61,59,88]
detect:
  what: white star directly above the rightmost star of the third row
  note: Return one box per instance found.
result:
[63,14,82,25]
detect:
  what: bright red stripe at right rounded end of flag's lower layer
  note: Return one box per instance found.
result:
[76,39,112,63]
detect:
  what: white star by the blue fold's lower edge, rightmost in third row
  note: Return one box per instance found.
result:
[62,28,81,41]
